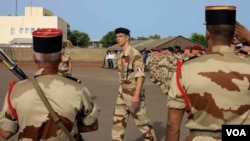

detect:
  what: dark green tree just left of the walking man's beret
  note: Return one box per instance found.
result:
[100,31,117,48]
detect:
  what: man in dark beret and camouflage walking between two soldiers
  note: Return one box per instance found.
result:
[112,28,156,141]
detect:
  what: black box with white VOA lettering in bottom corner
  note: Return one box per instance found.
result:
[222,125,250,141]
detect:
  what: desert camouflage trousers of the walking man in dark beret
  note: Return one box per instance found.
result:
[112,88,156,141]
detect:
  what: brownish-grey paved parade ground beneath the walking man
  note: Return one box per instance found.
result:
[0,62,188,141]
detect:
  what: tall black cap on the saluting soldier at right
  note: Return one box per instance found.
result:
[205,6,236,25]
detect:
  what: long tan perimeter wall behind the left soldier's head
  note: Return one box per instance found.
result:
[0,47,107,62]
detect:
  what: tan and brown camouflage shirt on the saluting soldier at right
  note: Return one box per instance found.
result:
[167,46,250,141]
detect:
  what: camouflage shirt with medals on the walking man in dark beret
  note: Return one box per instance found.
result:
[117,46,145,89]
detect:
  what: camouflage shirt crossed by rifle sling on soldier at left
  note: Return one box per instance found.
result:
[0,69,99,141]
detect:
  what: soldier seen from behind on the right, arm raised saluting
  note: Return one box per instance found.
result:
[166,6,250,141]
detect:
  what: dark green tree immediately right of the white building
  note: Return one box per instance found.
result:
[68,30,90,48]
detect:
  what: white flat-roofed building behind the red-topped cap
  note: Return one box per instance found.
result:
[0,7,67,47]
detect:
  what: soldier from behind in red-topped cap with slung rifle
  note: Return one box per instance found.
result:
[0,29,99,141]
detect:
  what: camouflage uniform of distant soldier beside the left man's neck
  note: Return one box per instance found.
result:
[58,54,71,76]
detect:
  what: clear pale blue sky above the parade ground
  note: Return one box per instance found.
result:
[0,0,250,40]
